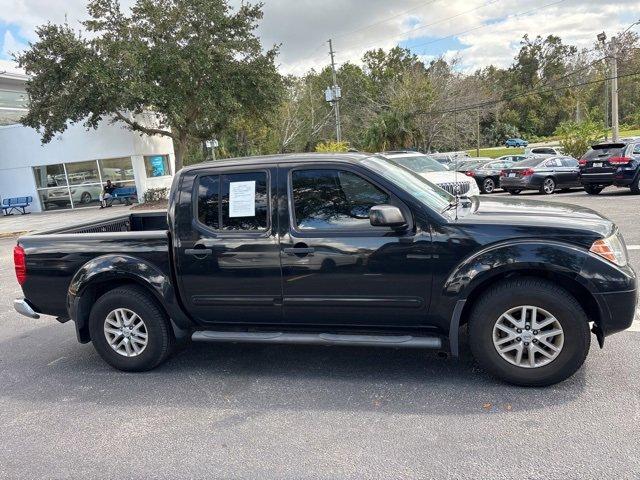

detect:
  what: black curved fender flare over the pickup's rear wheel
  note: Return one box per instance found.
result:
[67,254,191,341]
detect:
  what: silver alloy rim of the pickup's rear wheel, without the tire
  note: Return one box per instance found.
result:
[104,308,148,357]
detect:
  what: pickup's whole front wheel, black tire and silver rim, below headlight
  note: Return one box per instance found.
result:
[469,278,591,387]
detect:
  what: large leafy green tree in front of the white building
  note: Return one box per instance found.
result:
[17,0,282,168]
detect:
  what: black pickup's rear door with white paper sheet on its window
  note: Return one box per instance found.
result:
[174,165,282,324]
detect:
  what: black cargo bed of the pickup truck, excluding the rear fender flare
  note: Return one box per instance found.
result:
[18,211,171,317]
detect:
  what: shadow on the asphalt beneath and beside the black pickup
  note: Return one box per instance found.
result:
[0,325,586,415]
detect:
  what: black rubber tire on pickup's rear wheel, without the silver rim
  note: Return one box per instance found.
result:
[89,285,175,372]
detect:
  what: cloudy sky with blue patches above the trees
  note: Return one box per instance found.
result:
[0,0,640,74]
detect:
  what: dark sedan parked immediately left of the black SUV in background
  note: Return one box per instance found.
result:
[500,156,581,195]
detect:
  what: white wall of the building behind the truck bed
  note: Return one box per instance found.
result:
[0,117,175,211]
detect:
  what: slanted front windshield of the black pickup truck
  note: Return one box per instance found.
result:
[362,157,455,212]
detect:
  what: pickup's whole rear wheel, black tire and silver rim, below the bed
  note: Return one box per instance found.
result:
[89,286,174,372]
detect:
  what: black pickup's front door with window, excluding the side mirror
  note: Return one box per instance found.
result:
[279,164,432,326]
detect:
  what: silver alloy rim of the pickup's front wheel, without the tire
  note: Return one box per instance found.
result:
[493,305,564,368]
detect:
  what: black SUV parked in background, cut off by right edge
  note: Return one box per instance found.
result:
[579,140,640,195]
